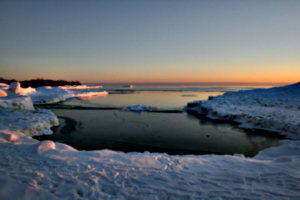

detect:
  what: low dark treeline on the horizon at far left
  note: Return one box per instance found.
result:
[0,78,81,88]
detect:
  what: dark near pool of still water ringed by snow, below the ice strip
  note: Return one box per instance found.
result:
[36,110,280,156]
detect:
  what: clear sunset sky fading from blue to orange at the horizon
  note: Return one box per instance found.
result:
[0,0,300,83]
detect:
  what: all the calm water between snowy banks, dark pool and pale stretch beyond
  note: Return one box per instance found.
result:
[36,89,283,156]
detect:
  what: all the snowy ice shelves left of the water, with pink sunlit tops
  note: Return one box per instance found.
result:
[0,82,108,136]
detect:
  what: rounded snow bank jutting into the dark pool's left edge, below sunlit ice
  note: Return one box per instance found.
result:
[0,109,59,136]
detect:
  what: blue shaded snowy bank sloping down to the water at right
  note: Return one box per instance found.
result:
[186,83,300,135]
